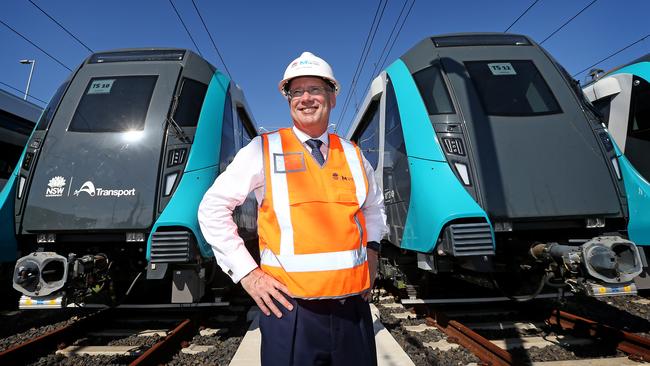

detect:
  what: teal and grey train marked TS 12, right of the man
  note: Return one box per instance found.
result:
[346,33,650,301]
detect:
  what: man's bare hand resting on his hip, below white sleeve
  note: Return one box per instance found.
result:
[240,268,293,318]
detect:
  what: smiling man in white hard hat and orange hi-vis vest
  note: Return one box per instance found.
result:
[198,52,386,366]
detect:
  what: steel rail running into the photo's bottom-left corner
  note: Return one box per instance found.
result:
[0,309,112,365]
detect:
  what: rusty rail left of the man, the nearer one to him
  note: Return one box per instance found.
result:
[129,319,198,366]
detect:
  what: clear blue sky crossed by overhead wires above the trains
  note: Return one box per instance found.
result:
[0,0,650,134]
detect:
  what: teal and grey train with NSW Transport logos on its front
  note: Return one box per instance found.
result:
[0,48,257,309]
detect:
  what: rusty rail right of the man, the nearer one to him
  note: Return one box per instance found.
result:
[426,313,516,366]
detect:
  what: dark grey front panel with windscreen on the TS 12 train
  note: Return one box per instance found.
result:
[437,44,621,220]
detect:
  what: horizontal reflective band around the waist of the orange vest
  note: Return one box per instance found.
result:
[260,247,367,272]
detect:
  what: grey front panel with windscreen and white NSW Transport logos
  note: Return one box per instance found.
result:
[22,61,182,232]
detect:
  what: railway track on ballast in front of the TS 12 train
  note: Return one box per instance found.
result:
[378,288,650,365]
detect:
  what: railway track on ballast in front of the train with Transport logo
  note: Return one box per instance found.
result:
[0,306,251,365]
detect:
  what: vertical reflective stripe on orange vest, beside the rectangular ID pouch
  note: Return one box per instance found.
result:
[267,132,293,255]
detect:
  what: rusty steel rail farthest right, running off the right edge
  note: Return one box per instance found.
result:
[547,310,650,362]
